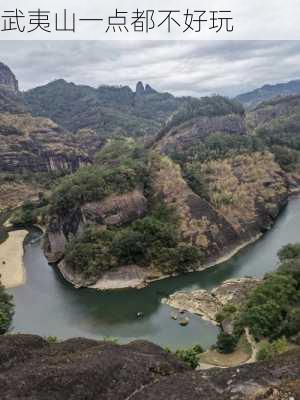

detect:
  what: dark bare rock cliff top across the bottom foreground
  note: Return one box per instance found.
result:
[0,335,300,400]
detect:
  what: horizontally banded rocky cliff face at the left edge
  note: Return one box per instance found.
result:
[0,113,103,173]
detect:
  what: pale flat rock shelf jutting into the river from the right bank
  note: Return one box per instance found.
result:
[162,277,260,322]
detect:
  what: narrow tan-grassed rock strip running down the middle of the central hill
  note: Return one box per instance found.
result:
[151,157,238,258]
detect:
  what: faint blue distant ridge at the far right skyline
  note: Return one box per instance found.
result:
[235,79,300,109]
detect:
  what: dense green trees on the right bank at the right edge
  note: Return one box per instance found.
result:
[218,244,300,348]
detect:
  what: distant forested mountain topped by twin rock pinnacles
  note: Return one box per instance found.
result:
[24,79,185,137]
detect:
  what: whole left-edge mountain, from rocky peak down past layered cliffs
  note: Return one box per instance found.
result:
[0,63,103,211]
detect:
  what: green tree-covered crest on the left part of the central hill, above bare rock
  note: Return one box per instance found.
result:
[50,138,147,215]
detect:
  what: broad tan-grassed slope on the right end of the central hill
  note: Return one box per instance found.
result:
[199,152,288,234]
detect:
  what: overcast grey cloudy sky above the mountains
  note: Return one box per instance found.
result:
[0,41,300,97]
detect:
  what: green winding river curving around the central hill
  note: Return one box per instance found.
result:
[10,197,300,349]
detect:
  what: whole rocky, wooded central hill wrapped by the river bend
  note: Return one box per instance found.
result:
[45,98,289,288]
